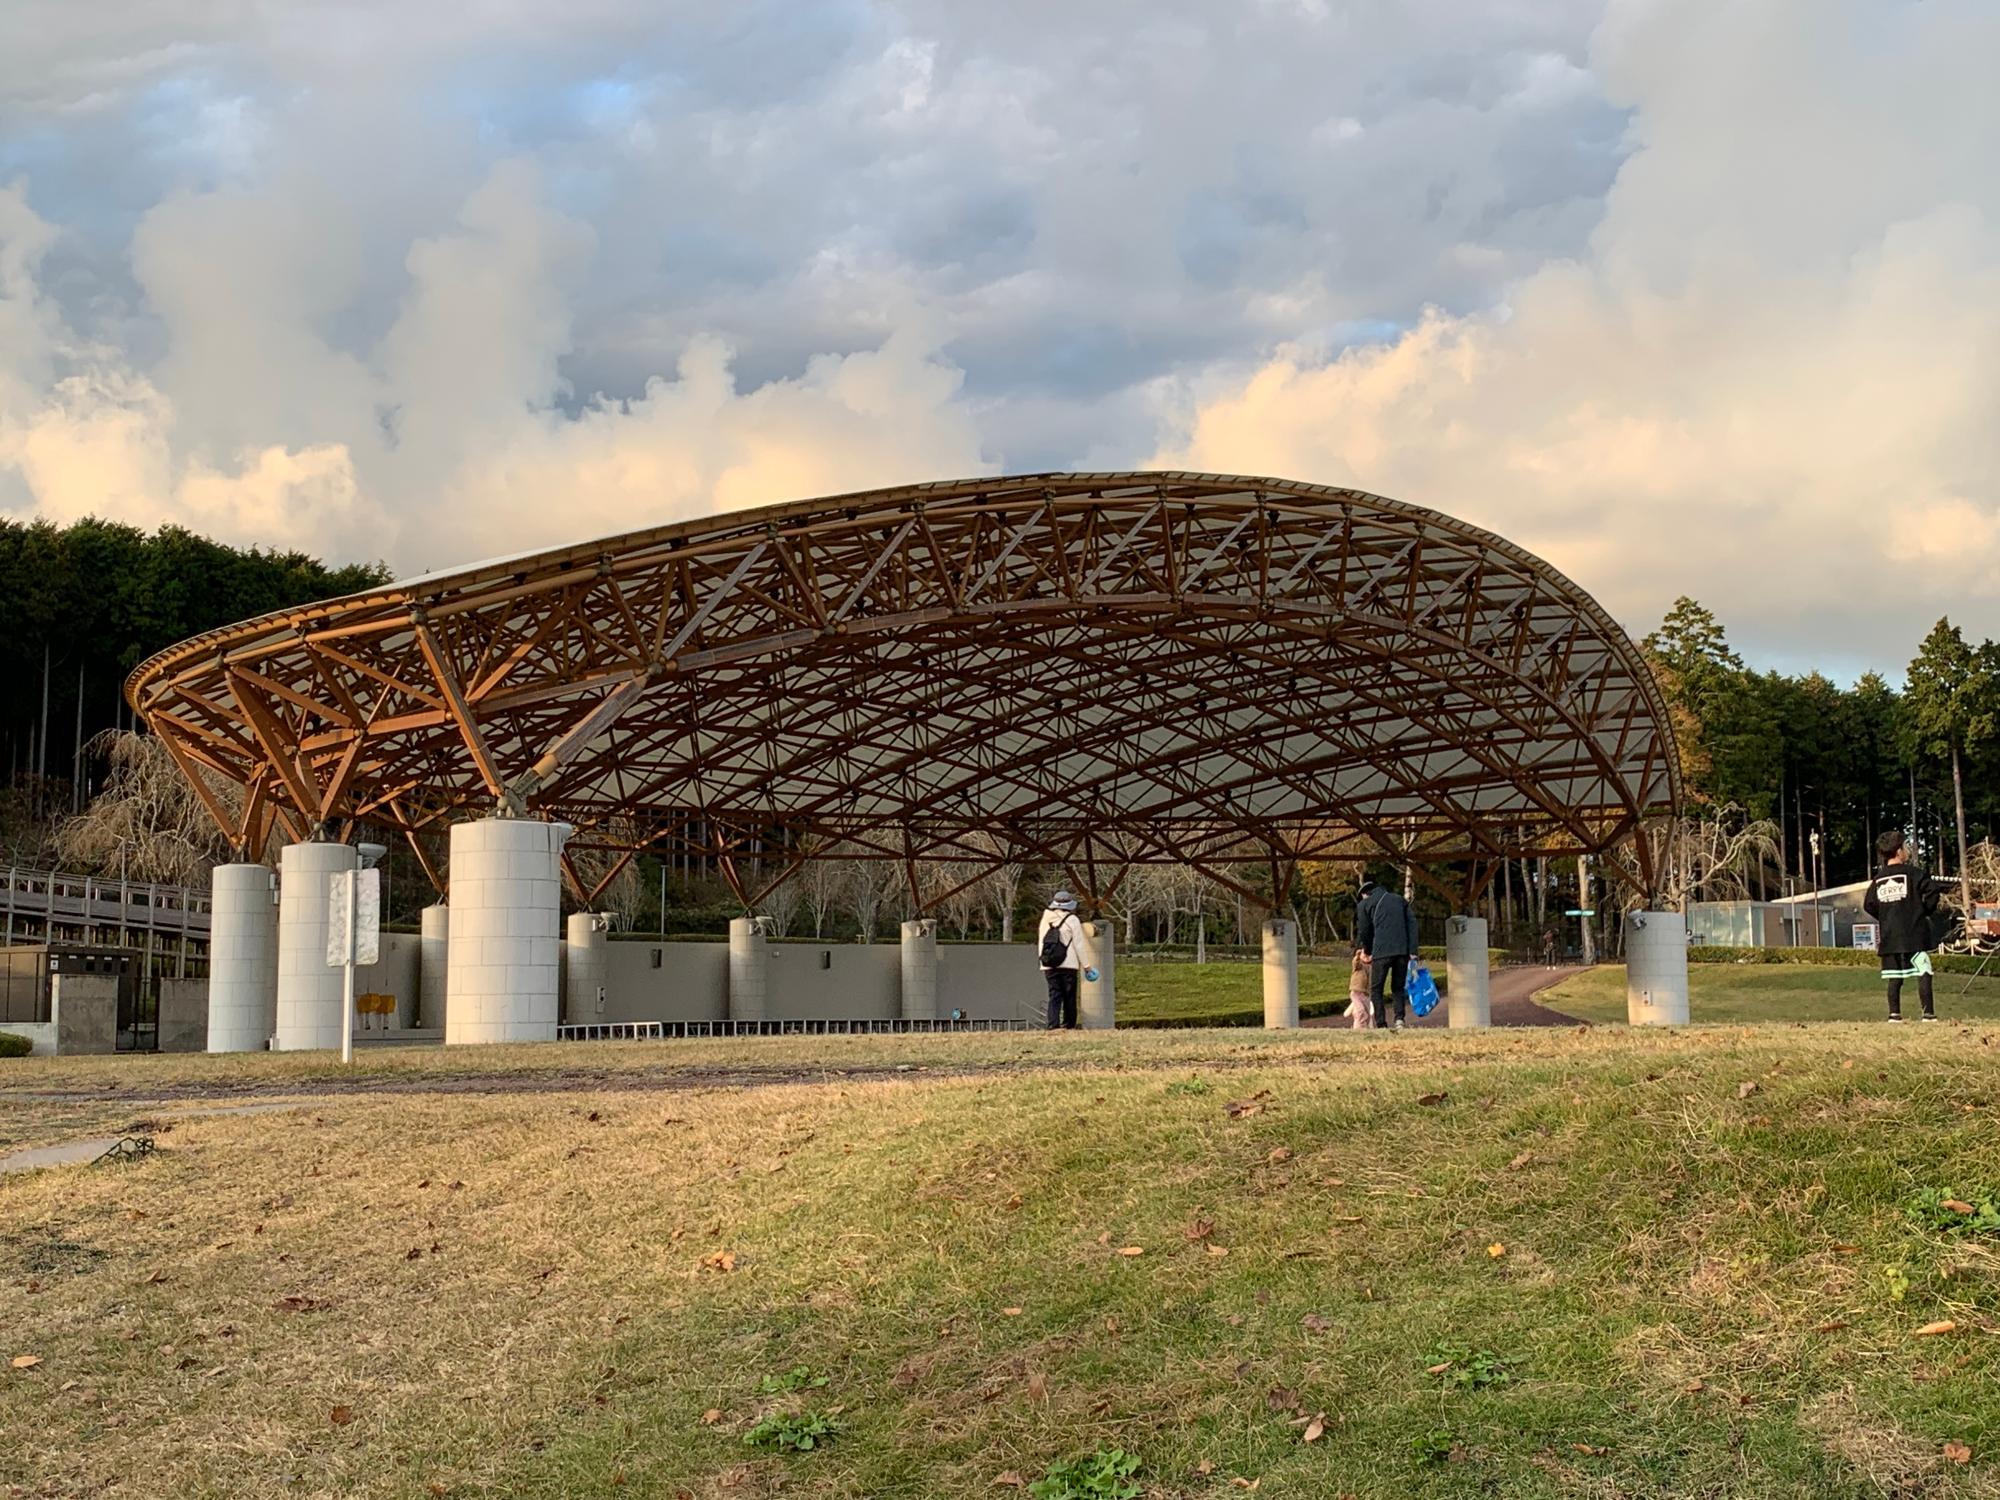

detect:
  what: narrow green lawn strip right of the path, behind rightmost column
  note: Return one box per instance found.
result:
[1536,962,2000,1026]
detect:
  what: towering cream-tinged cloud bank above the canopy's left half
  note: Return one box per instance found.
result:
[0,162,990,572]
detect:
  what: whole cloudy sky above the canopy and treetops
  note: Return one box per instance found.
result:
[0,0,2000,676]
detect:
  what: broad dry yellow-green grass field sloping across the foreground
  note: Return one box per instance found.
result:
[0,1024,2000,1500]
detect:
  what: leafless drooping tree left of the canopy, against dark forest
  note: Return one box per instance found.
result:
[54,730,242,886]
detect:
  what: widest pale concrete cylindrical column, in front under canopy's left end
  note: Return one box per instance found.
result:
[444,818,568,1044]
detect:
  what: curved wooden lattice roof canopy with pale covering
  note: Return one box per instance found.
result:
[126,474,1678,894]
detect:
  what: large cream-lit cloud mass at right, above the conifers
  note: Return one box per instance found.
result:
[1156,0,2000,664]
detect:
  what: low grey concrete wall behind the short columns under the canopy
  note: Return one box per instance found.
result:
[594,938,1048,1020]
